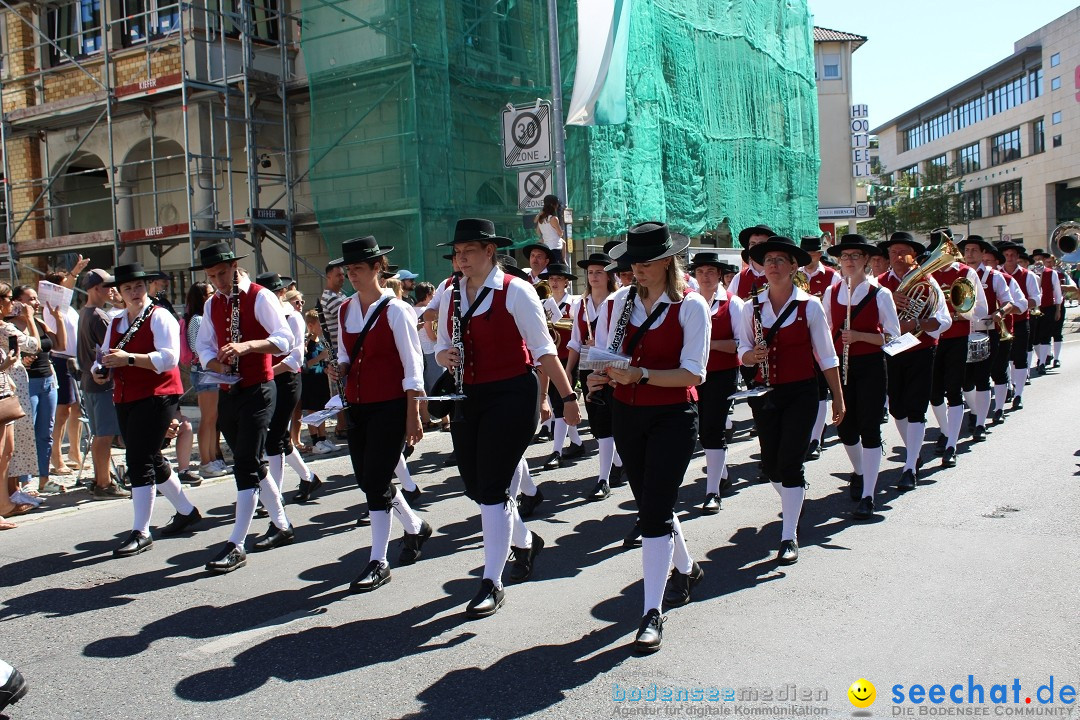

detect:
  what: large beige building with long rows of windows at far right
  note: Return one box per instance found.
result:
[873,9,1080,249]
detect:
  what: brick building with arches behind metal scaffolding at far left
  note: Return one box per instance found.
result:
[0,0,313,298]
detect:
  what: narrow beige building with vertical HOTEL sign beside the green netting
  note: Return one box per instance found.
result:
[813,26,869,235]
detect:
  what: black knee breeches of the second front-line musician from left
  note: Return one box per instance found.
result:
[217,380,278,490]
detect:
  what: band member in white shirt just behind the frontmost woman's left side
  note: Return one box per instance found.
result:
[566,253,625,500]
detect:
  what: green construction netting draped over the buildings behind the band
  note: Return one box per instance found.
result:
[301,0,819,276]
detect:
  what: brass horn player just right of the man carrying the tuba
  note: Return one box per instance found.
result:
[930,228,987,467]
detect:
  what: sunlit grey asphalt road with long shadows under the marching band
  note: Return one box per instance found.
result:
[0,336,1080,719]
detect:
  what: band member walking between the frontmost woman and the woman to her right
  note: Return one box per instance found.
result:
[690,253,743,515]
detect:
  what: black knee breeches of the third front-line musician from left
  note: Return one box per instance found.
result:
[346,397,408,513]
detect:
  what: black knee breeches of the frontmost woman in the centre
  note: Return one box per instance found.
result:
[611,400,695,538]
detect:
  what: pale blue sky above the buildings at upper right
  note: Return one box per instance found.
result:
[807,0,1077,127]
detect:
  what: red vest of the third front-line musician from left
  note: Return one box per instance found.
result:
[338,295,405,405]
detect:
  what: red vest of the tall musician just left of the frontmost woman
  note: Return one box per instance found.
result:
[462,274,532,385]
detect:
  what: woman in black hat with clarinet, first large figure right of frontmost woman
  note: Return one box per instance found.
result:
[739,237,845,565]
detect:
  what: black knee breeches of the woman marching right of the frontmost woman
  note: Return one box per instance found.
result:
[751,378,812,488]
